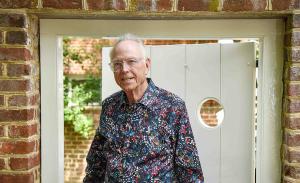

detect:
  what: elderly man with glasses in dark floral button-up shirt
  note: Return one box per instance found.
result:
[83,34,203,183]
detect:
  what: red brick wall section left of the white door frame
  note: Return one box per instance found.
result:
[0,13,40,183]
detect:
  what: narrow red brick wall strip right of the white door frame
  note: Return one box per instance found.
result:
[283,14,300,183]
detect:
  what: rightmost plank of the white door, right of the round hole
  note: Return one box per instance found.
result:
[221,43,255,183]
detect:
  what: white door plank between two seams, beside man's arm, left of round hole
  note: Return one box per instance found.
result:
[186,44,220,183]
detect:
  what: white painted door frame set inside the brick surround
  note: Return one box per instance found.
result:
[40,19,284,183]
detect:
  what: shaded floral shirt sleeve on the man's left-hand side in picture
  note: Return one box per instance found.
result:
[83,108,107,183]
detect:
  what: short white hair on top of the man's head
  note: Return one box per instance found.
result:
[109,33,146,60]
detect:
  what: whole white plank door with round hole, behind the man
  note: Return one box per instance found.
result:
[102,43,255,183]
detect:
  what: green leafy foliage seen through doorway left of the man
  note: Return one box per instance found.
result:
[63,38,101,138]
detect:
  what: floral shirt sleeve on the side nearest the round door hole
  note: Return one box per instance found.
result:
[175,105,204,183]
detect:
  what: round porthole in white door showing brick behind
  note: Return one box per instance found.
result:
[198,98,224,127]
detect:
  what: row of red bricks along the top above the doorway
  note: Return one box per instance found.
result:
[0,0,300,12]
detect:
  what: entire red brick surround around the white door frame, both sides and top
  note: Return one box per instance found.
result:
[0,0,300,183]
